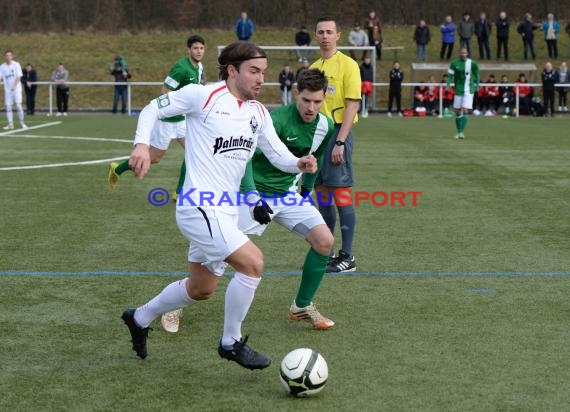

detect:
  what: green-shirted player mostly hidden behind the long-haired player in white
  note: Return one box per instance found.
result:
[107,35,206,193]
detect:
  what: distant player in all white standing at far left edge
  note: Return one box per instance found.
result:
[0,50,28,130]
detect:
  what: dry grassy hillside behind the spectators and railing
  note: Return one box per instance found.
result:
[0,26,570,110]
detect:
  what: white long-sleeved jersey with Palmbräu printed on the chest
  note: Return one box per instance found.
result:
[134,82,299,214]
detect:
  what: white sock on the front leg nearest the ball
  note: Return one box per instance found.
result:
[221,272,261,347]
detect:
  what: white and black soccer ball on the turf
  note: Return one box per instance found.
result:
[280,348,329,397]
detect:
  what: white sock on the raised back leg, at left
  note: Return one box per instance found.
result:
[135,278,196,328]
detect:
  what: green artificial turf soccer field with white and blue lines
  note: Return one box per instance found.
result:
[0,116,570,411]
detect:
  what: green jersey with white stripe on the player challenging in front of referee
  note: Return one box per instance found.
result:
[240,103,334,196]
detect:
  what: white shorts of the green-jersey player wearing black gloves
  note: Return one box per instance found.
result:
[238,193,325,239]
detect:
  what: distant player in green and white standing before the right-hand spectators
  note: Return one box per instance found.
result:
[446,48,474,139]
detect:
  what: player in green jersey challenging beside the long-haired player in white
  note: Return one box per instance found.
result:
[238,69,334,329]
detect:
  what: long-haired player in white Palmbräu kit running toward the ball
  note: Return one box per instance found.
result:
[122,41,317,369]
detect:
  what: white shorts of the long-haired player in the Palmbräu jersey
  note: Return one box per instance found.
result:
[176,207,249,276]
